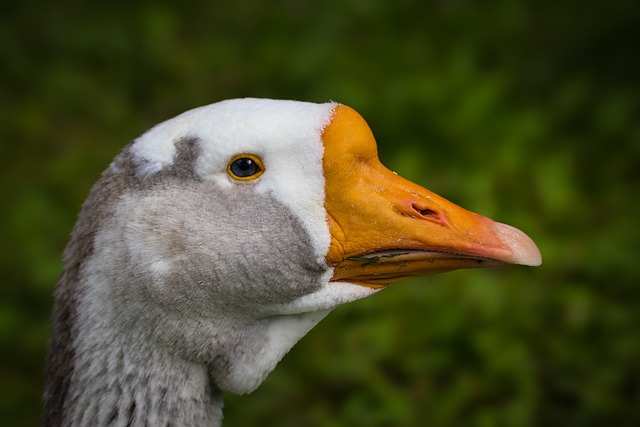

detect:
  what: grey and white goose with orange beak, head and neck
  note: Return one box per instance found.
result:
[43,99,541,426]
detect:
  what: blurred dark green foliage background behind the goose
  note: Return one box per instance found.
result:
[0,0,640,427]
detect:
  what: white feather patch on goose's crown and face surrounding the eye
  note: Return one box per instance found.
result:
[132,99,336,259]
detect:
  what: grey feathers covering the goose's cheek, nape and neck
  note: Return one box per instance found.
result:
[43,138,328,426]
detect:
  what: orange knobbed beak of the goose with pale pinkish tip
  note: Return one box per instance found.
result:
[322,105,541,287]
